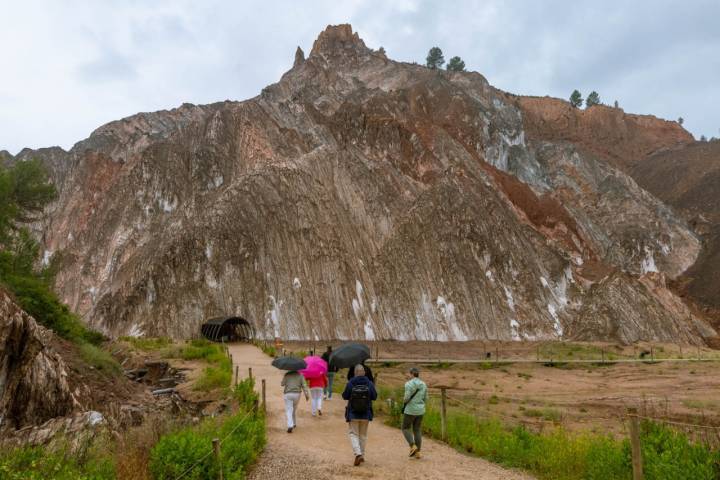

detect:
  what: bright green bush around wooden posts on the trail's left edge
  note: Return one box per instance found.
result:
[150,379,266,480]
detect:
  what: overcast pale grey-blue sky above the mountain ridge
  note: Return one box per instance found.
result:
[0,0,720,153]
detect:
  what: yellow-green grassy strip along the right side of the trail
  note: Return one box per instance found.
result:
[378,388,720,480]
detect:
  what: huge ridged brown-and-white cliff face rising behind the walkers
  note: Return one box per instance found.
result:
[14,25,714,342]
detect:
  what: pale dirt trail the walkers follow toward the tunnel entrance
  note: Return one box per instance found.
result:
[230,344,532,480]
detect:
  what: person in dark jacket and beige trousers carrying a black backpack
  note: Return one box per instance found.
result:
[343,365,377,467]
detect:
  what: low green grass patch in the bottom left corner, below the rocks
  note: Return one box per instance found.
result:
[0,447,115,480]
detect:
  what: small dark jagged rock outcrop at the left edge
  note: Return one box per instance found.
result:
[0,290,79,430]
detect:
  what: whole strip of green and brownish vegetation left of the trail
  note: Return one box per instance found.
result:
[0,379,266,480]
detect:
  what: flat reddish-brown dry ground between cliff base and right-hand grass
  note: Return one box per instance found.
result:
[278,342,720,433]
